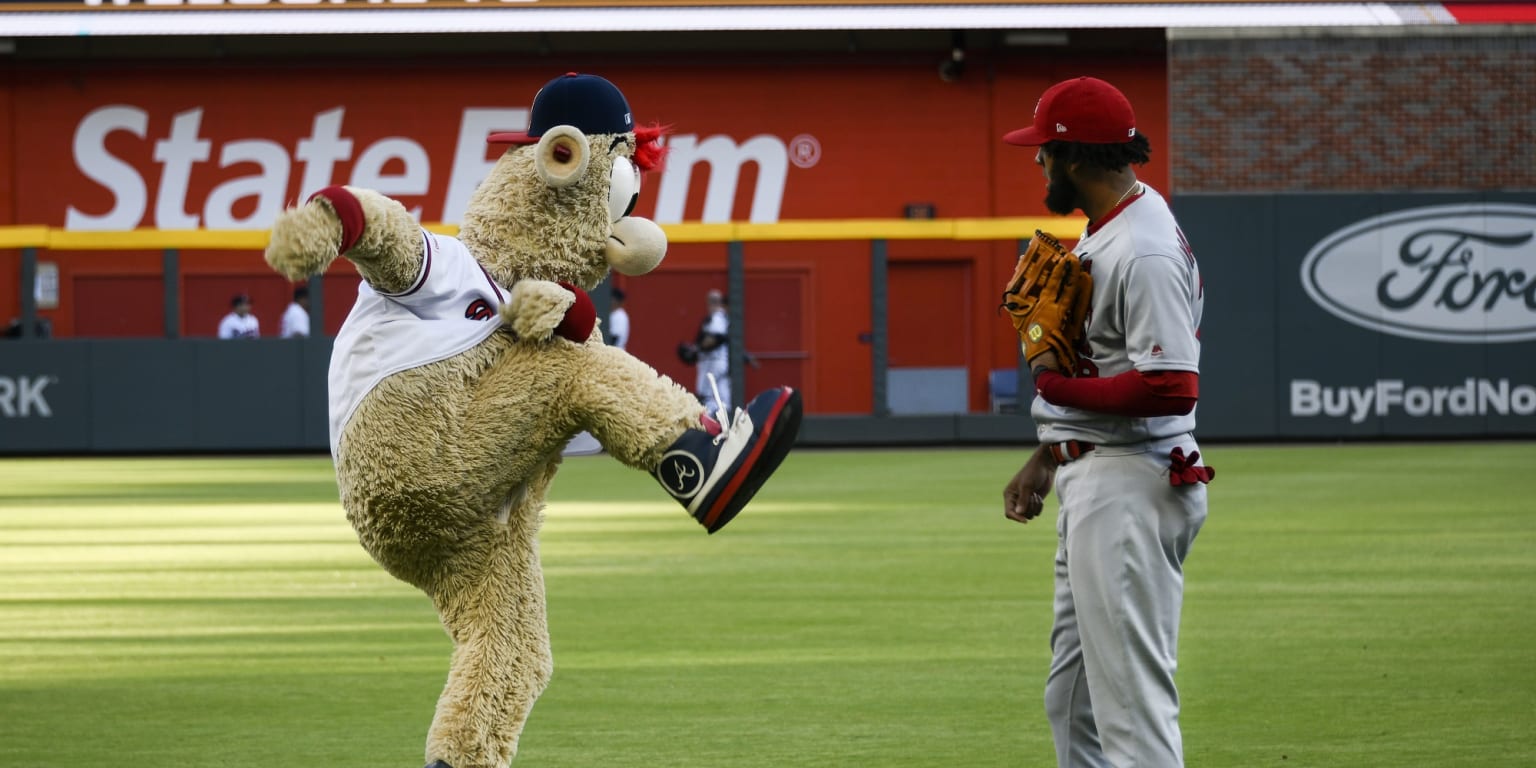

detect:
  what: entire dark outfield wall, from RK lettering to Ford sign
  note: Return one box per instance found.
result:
[0,194,1536,453]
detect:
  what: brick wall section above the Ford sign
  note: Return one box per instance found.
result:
[1154,35,1536,194]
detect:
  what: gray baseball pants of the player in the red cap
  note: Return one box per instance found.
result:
[1046,435,1206,768]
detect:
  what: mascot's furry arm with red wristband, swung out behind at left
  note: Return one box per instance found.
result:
[266,186,422,293]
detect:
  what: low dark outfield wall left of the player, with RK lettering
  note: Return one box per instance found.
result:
[0,338,1034,455]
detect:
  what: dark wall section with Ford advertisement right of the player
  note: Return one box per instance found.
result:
[1175,194,1536,438]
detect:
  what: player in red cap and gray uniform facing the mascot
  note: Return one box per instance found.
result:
[1003,77,1213,768]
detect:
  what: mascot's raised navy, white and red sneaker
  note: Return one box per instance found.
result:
[651,387,800,533]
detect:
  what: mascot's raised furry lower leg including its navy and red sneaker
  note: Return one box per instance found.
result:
[570,344,802,533]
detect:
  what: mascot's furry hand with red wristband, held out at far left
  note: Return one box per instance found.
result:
[266,187,362,281]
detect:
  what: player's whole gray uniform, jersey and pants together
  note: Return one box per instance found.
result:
[1034,184,1206,768]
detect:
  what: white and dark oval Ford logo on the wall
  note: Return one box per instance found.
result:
[1301,203,1536,344]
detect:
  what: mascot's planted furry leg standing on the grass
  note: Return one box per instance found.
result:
[427,465,553,768]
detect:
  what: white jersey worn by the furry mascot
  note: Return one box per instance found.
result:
[329,230,507,458]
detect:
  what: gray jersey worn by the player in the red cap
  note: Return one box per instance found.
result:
[1031,184,1204,445]
